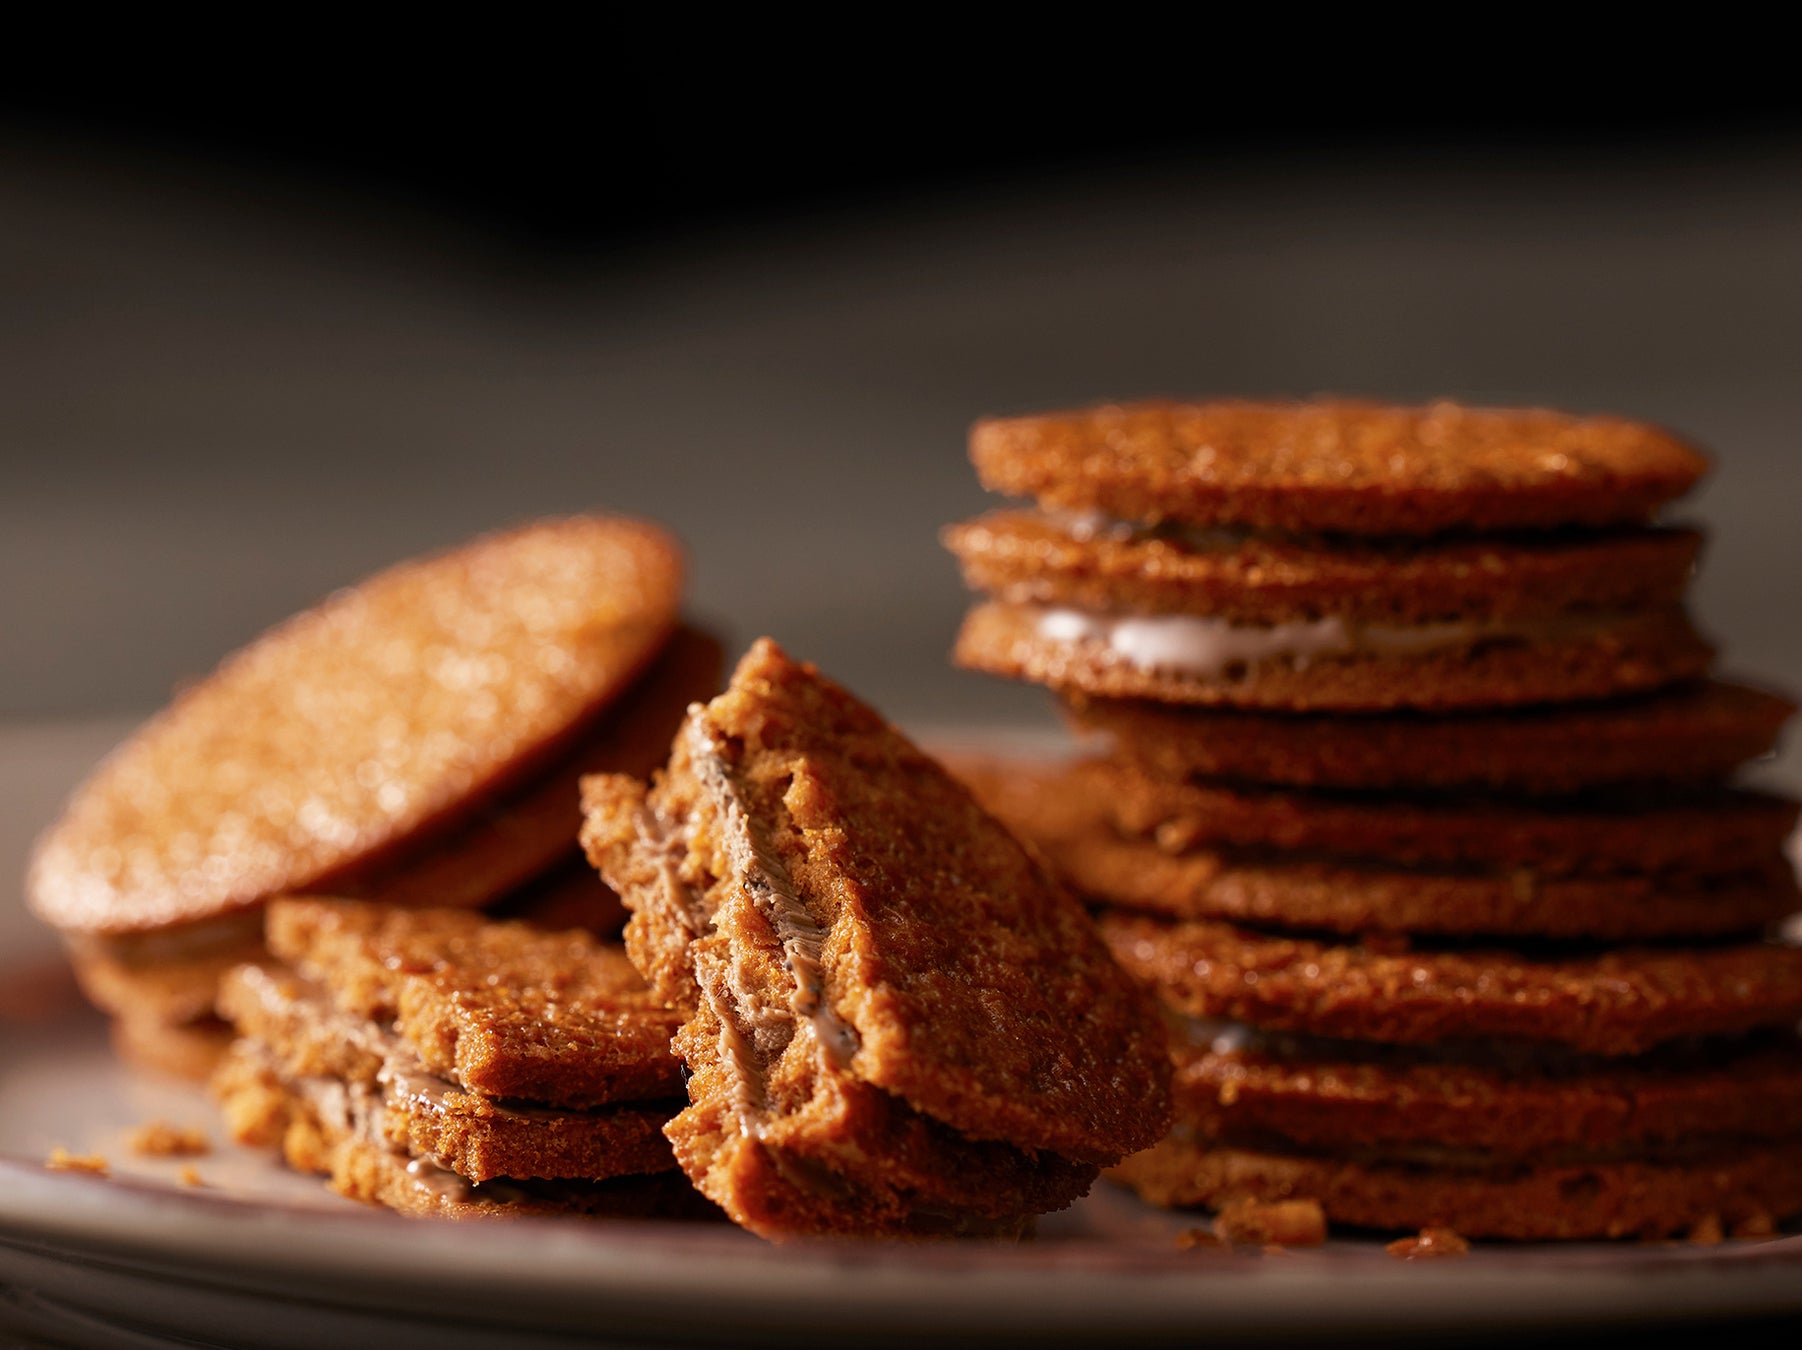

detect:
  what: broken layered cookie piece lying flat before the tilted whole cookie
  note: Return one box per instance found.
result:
[213,899,708,1218]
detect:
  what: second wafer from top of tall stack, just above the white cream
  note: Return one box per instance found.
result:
[944,510,1701,625]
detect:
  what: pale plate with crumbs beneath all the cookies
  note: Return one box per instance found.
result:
[0,726,1802,1348]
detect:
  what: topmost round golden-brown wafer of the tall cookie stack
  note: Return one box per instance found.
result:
[969,400,1708,535]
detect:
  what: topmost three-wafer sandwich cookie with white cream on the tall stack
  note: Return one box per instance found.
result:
[946,402,1712,712]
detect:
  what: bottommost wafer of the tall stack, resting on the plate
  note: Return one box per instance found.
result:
[1110,1137,1802,1242]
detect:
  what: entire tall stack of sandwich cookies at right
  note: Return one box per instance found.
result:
[948,394,1802,1238]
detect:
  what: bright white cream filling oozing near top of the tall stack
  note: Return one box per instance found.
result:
[1027,606,1622,680]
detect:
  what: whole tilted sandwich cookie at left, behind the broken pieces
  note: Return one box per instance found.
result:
[27,517,721,1076]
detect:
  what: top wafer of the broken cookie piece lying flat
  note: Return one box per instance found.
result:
[268,899,681,1107]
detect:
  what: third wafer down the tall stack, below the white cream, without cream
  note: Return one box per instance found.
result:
[955,602,1714,712]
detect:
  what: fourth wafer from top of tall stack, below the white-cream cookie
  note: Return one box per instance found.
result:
[1069,680,1795,793]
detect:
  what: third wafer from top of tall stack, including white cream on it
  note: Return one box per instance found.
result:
[955,600,1714,712]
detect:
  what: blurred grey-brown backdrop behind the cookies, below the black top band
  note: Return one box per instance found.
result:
[0,141,1802,778]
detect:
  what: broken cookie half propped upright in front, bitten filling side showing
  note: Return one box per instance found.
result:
[582,640,1169,1238]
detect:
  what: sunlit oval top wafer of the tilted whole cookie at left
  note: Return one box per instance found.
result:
[29,517,683,932]
